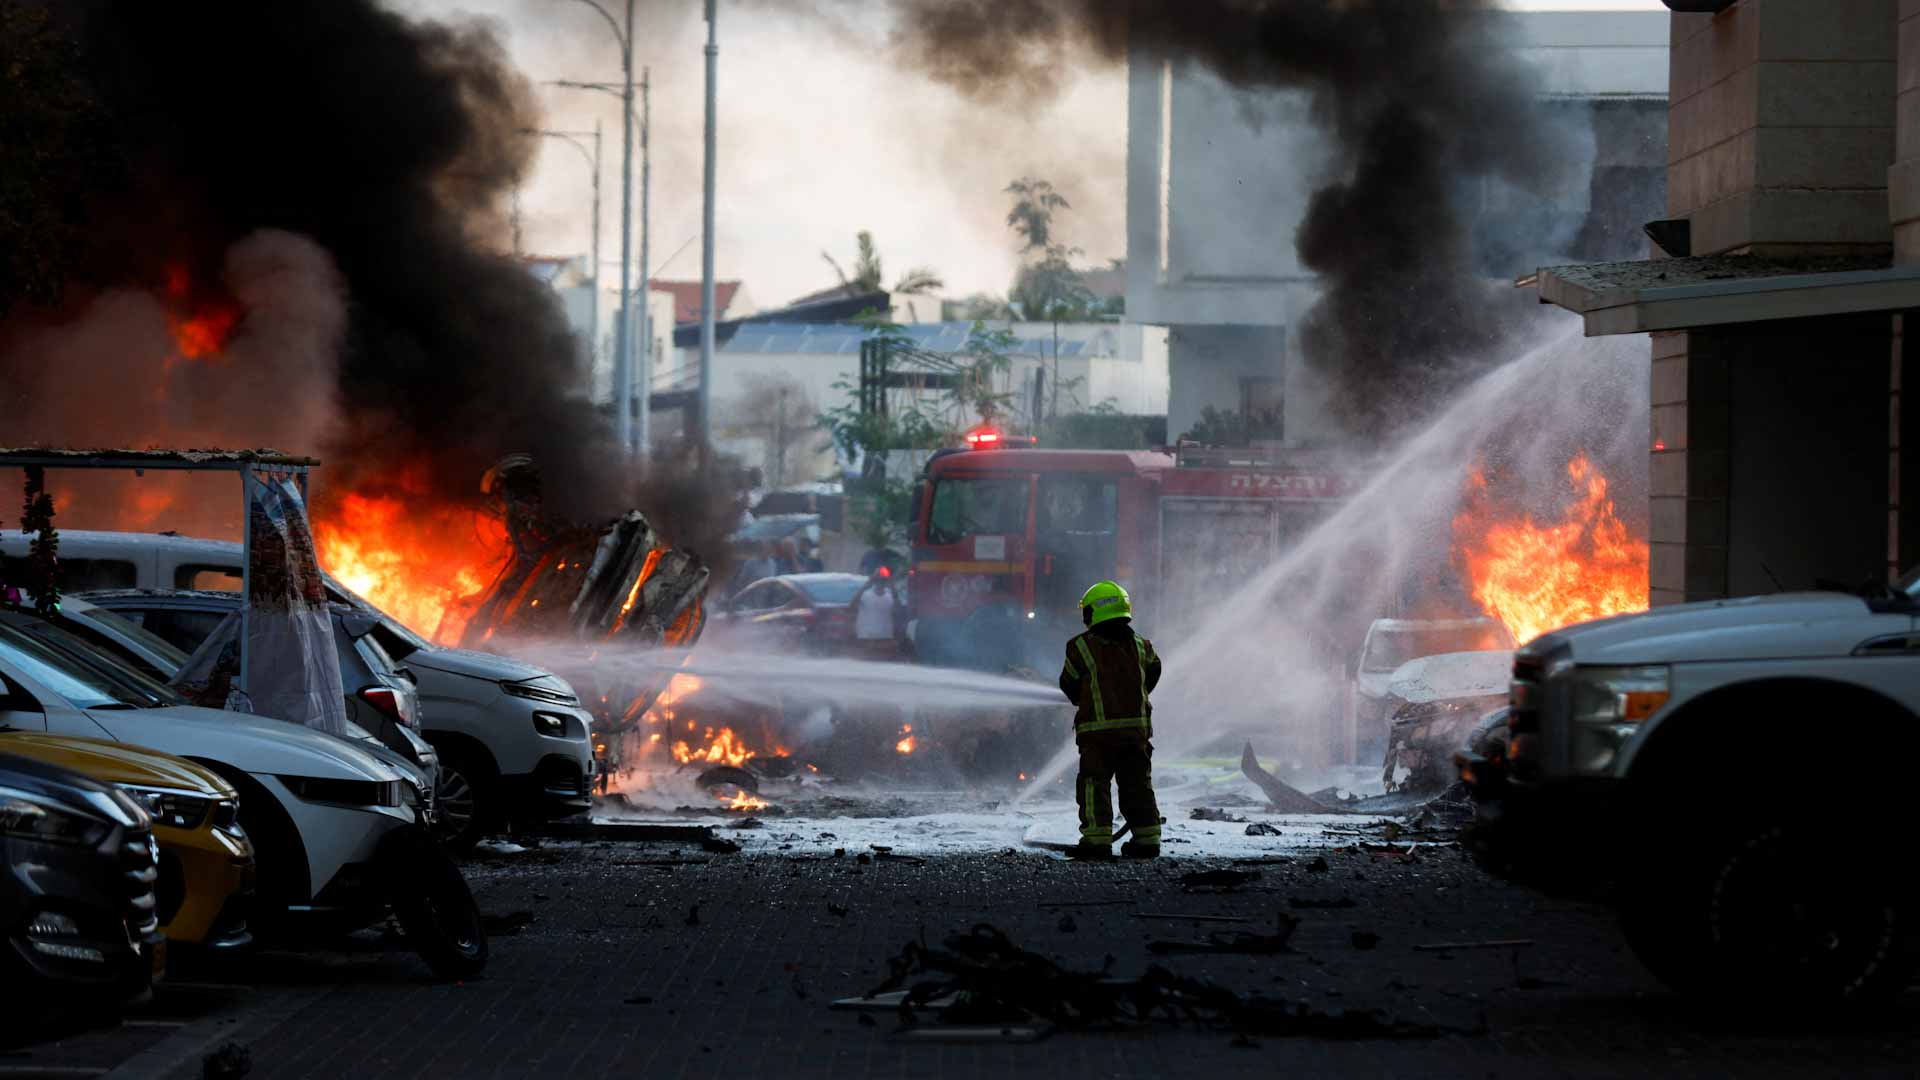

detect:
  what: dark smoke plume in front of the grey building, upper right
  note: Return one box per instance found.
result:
[893,0,1576,436]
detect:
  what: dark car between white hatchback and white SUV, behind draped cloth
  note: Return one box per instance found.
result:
[61,588,440,792]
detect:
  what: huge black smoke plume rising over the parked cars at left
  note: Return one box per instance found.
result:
[0,0,626,519]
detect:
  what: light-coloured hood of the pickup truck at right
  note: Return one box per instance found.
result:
[1526,592,1912,665]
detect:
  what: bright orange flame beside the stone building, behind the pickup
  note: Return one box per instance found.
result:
[1453,454,1647,644]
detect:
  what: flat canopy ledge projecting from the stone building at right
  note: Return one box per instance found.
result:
[1515,254,1920,338]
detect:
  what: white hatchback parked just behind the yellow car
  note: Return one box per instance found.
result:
[0,607,488,978]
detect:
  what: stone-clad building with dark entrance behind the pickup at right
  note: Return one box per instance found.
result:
[1538,0,1920,603]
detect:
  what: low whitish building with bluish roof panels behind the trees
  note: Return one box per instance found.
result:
[655,321,1167,486]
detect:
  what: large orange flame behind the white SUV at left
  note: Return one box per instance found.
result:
[313,492,507,644]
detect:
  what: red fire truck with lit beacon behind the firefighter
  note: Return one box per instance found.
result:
[908,430,1359,671]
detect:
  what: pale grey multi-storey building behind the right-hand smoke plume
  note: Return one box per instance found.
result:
[1127,12,1667,442]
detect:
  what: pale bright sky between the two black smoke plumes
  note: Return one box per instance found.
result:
[401,0,1661,307]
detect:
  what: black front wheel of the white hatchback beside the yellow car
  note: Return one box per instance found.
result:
[380,828,488,978]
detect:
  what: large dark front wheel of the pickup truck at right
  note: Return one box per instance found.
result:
[1620,815,1920,1017]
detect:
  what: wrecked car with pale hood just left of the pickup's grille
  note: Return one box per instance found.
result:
[1380,650,1513,792]
